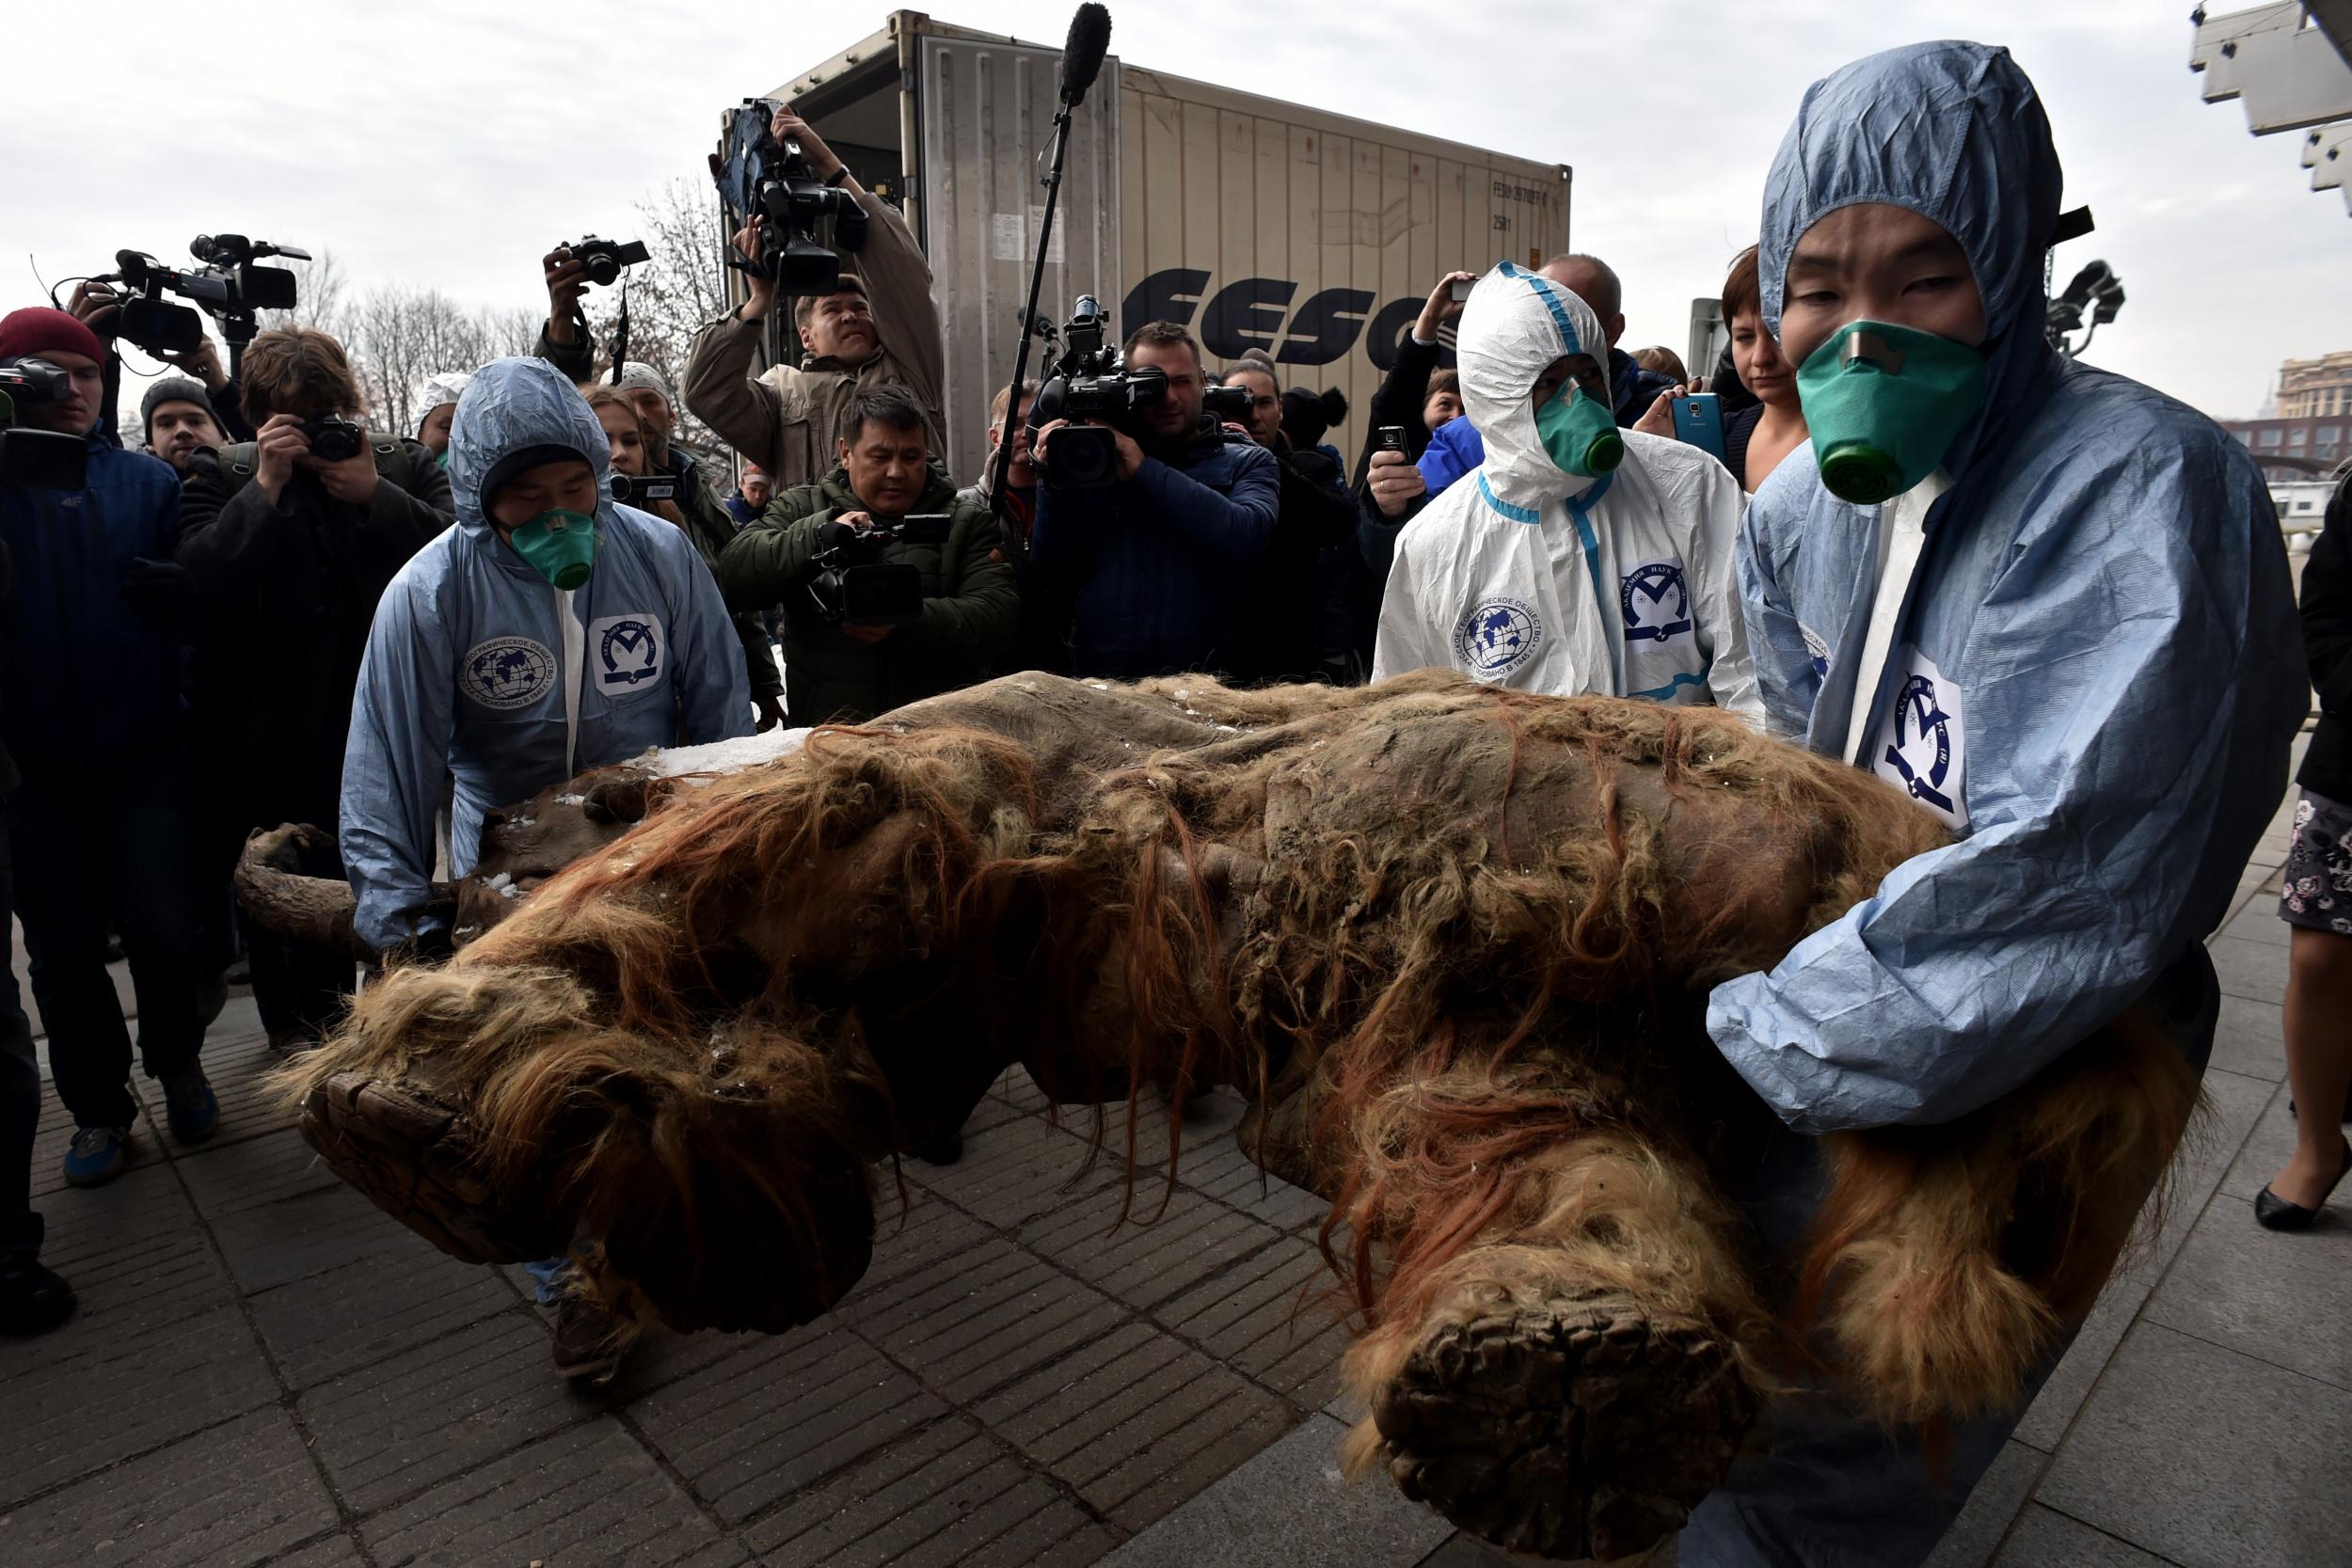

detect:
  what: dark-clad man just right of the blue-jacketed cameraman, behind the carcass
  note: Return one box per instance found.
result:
[1226,359,1358,687]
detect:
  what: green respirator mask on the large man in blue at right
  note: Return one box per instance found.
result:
[1797,322,1985,505]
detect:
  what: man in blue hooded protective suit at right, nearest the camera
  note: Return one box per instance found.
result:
[1682,42,2308,1568]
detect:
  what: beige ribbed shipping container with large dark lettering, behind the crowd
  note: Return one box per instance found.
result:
[767,11,1569,480]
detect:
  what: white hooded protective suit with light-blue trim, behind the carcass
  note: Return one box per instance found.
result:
[1372,261,1757,712]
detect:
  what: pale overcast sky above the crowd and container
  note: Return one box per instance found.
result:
[0,0,2352,416]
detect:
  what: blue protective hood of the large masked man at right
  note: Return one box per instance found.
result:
[1757,42,2060,477]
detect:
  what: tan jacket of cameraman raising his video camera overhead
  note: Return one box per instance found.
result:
[685,190,948,491]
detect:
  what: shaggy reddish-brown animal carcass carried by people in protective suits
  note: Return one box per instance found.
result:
[247,673,2197,1559]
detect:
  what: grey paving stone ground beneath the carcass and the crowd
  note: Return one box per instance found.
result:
[0,770,2352,1568]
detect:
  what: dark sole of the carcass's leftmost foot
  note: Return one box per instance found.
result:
[301,1072,569,1262]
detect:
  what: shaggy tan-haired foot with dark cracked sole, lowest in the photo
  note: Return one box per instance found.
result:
[1348,1129,1762,1559]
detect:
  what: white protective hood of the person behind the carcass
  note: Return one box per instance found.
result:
[1454,261,1609,508]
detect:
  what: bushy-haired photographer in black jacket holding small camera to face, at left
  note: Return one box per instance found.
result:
[177,326,454,1051]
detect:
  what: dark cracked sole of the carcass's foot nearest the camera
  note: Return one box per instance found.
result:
[1374,1298,1755,1561]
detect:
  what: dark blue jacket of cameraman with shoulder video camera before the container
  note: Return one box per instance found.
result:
[1030,430,1279,679]
